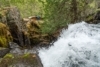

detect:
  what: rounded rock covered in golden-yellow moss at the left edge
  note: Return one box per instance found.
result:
[0,22,12,47]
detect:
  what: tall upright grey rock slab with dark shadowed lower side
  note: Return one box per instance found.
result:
[6,7,25,46]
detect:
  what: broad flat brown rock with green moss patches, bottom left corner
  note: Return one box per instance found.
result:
[0,53,43,67]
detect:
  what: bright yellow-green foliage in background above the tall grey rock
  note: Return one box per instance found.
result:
[0,0,43,17]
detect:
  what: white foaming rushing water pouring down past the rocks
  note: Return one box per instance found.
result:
[39,21,100,67]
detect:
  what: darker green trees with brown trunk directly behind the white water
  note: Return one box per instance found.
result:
[39,0,98,33]
